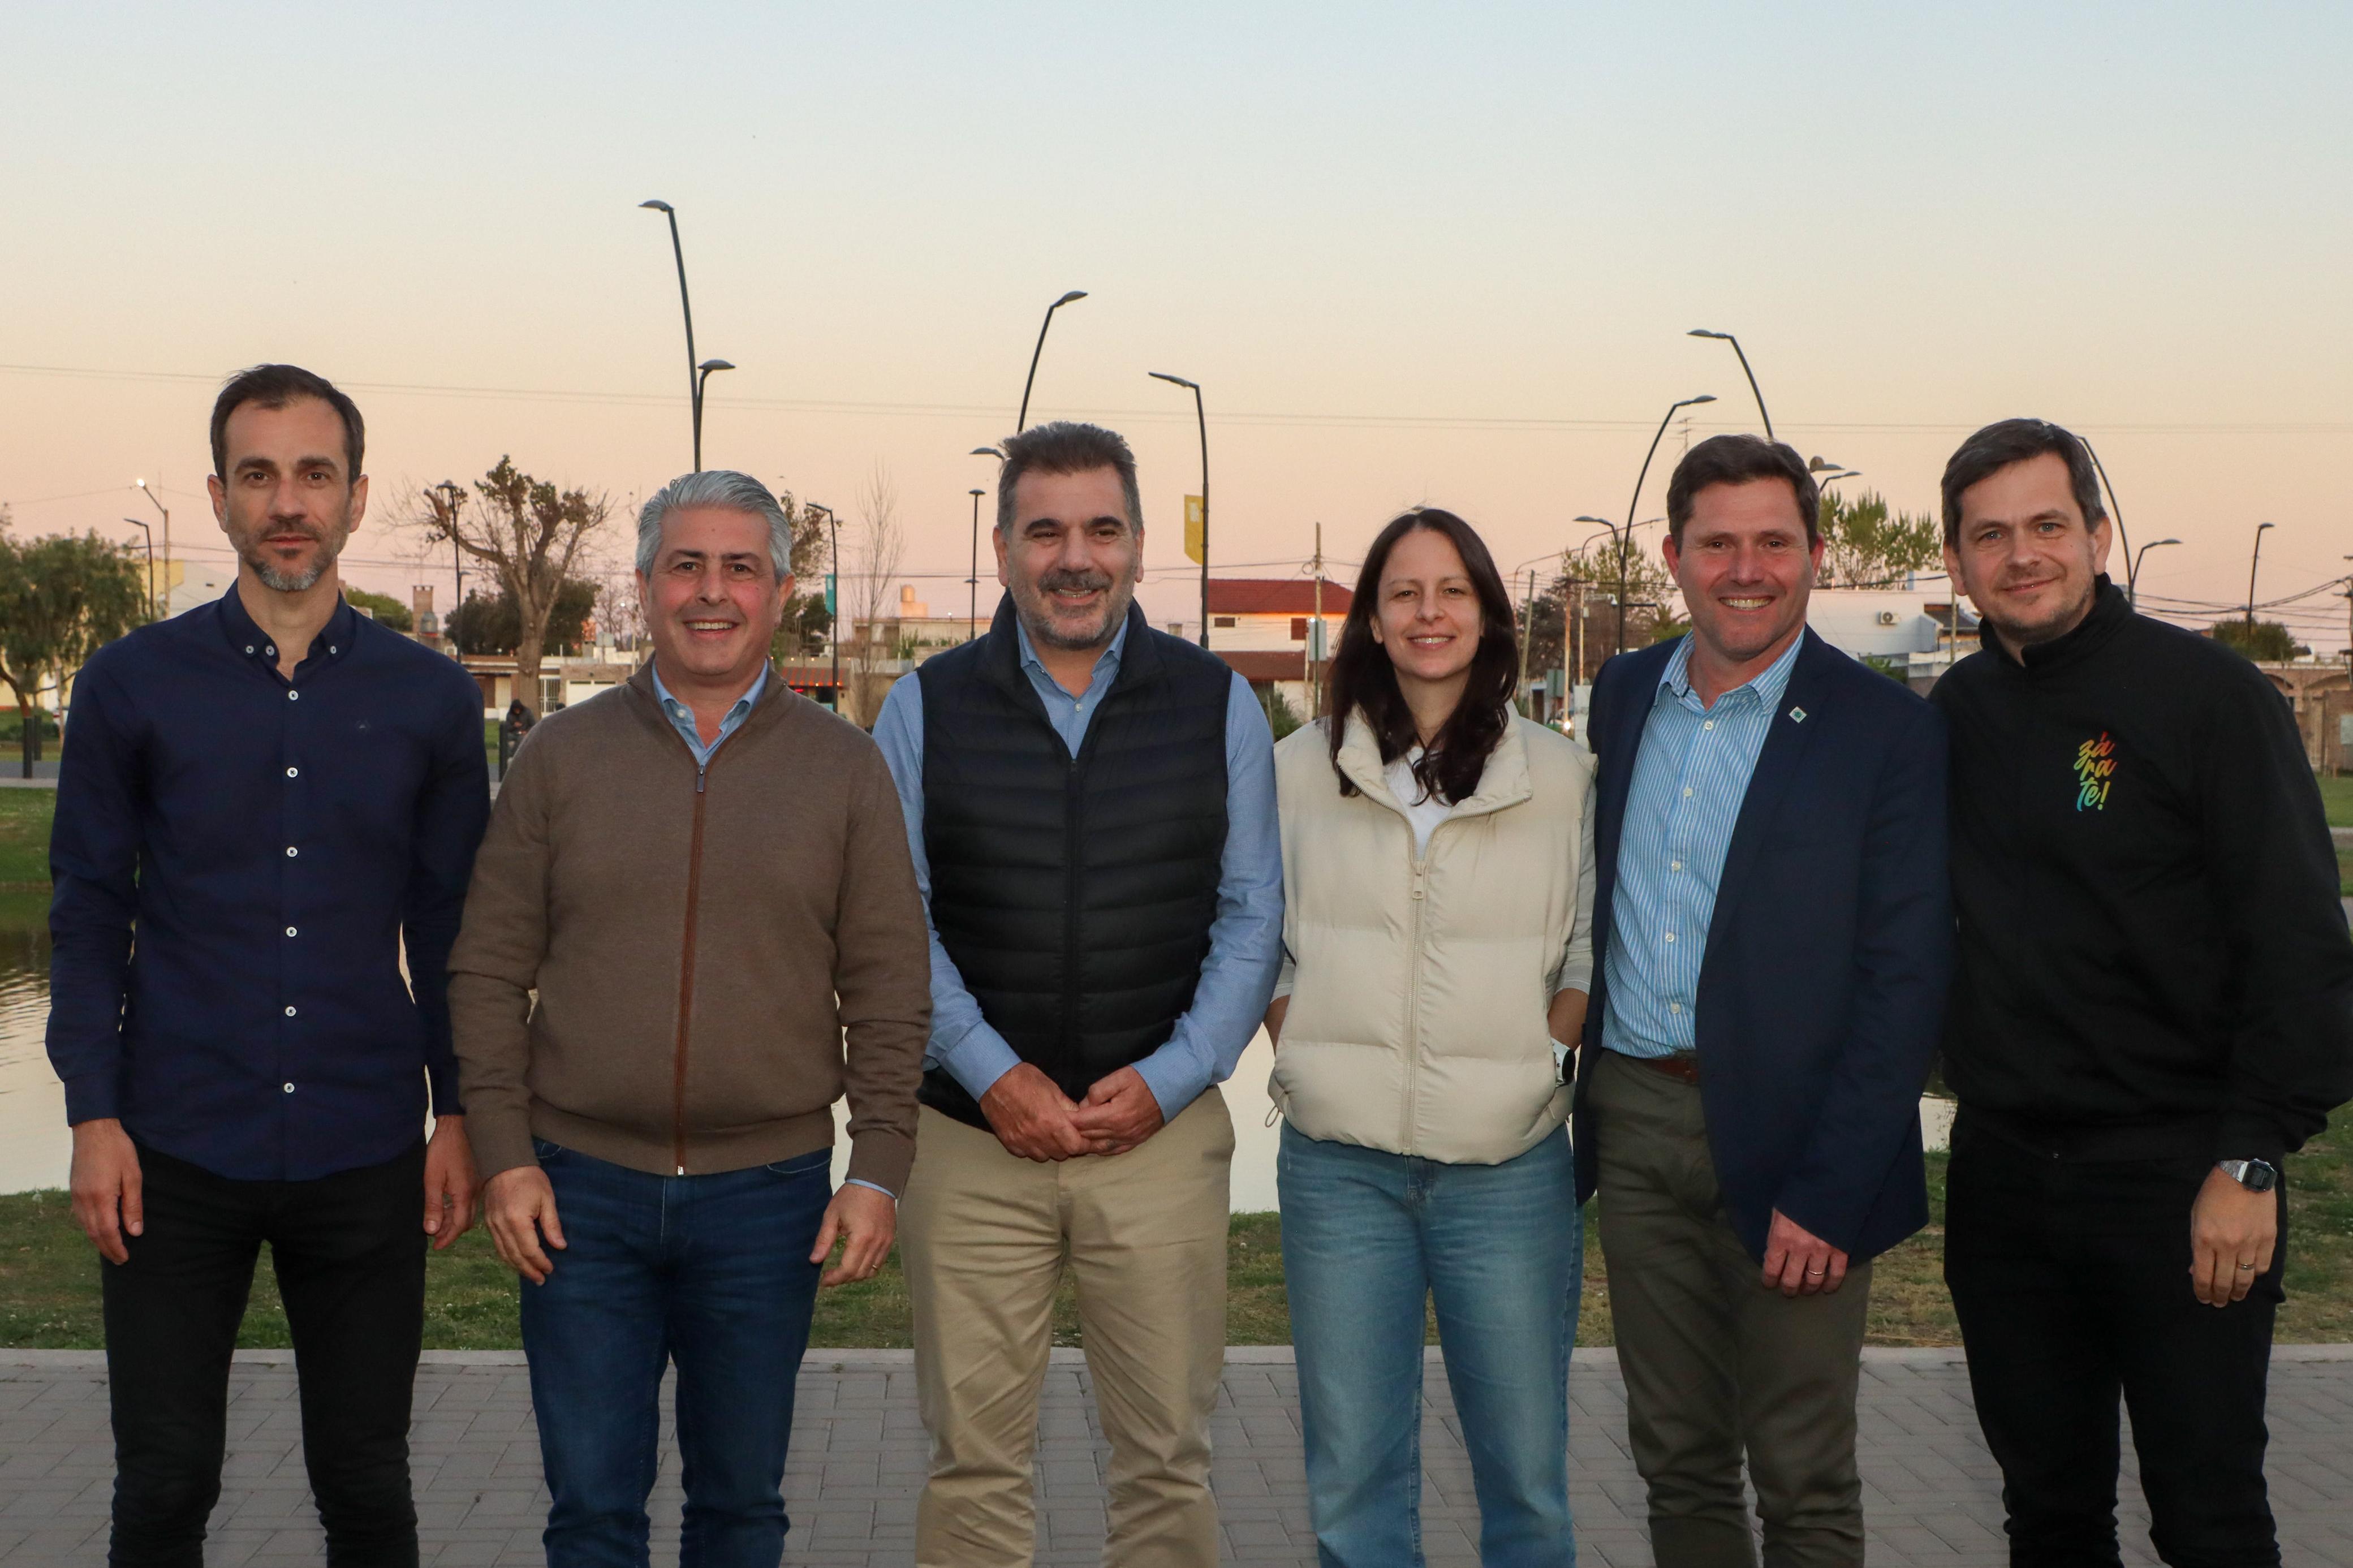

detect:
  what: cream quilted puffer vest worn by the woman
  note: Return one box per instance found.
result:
[1268,718,1593,1165]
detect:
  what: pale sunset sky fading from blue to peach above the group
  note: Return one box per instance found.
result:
[14,0,2353,650]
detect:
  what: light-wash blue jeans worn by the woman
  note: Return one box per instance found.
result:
[1275,1123,1586,1568]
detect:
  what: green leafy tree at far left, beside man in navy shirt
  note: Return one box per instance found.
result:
[0,532,148,779]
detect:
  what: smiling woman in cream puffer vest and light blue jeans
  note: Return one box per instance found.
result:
[1266,509,1593,1566]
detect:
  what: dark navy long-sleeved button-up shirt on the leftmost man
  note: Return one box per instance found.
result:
[49,589,489,1182]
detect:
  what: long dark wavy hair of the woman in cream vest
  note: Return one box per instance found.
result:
[1325,506,1520,805]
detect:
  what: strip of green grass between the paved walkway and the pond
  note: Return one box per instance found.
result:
[0,1126,2353,1349]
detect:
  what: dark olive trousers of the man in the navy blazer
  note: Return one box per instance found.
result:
[1586,1050,1871,1568]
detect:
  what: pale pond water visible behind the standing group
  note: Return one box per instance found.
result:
[0,892,1275,1213]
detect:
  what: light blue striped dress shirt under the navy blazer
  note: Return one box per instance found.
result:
[1602,634,1805,1057]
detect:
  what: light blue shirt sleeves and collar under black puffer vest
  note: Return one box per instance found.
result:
[876,624,1282,1121]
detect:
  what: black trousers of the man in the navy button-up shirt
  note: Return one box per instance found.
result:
[99,1142,426,1568]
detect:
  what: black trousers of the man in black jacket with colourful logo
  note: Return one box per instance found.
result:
[1943,1112,2287,1568]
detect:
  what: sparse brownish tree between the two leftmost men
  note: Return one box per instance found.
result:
[407,456,614,716]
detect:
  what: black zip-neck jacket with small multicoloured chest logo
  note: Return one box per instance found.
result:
[1934,577,2353,1163]
